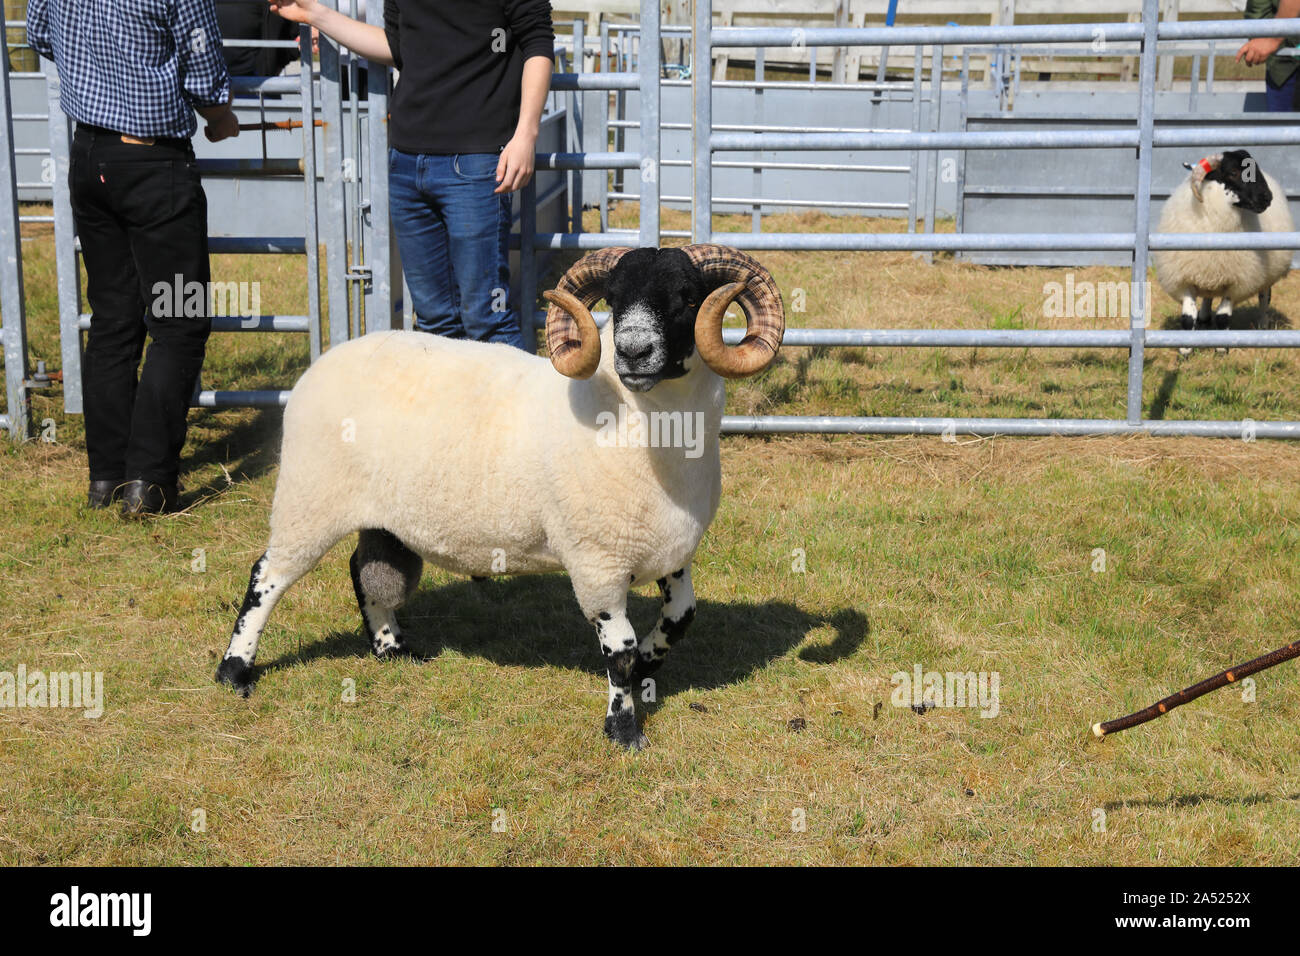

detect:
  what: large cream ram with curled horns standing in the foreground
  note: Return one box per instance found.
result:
[217,245,785,749]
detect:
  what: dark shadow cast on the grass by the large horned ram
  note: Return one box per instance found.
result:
[257,575,870,698]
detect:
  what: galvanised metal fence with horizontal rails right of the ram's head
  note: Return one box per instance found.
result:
[692,0,1300,438]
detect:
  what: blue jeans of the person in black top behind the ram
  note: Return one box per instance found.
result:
[389,150,532,351]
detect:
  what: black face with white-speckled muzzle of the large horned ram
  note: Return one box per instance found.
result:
[605,248,710,392]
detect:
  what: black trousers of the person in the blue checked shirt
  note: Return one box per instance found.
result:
[69,125,211,484]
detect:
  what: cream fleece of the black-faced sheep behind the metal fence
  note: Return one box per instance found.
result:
[1152,173,1294,303]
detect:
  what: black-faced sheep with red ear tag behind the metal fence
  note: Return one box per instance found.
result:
[1152,150,1295,329]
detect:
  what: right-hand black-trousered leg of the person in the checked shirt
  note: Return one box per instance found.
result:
[92,135,211,497]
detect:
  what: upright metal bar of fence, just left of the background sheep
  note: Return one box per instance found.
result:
[1126,0,1160,424]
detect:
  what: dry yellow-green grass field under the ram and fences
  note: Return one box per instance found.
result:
[0,211,1300,865]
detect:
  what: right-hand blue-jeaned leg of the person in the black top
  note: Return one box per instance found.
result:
[429,152,525,349]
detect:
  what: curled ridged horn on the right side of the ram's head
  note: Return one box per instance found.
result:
[684,243,785,378]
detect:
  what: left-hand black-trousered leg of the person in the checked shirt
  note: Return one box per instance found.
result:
[69,133,146,486]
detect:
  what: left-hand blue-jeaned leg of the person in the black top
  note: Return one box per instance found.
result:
[389,150,465,338]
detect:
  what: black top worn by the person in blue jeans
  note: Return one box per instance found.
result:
[384,0,555,153]
